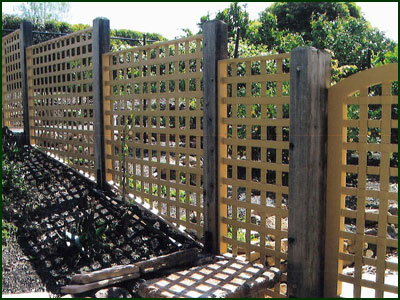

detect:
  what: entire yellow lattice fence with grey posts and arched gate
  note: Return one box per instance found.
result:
[2,18,398,297]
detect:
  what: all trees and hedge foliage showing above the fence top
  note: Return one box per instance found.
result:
[2,2,398,83]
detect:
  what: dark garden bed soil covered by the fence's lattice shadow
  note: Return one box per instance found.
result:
[2,131,200,297]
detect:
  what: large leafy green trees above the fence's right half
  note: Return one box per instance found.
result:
[198,2,397,83]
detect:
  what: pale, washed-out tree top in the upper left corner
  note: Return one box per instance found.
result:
[14,2,70,24]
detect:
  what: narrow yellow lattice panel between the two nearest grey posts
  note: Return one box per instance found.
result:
[219,54,290,296]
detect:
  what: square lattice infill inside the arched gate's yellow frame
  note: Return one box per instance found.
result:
[338,82,398,298]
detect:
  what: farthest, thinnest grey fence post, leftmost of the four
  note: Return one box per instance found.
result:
[19,21,33,145]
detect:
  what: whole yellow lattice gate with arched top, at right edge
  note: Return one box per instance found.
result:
[327,64,398,298]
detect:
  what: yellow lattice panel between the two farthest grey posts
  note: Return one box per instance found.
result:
[27,29,95,178]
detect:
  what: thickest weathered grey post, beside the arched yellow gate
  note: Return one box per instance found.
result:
[287,47,331,298]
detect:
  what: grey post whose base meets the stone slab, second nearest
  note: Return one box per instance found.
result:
[203,20,228,254]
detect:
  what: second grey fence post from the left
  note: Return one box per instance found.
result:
[92,18,110,189]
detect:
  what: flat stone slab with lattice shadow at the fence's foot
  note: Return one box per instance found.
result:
[138,259,279,298]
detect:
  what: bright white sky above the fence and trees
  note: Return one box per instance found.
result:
[2,2,399,42]
